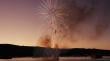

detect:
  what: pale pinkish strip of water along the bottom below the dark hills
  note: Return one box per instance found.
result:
[0,57,110,61]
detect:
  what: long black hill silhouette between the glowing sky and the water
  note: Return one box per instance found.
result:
[0,44,110,59]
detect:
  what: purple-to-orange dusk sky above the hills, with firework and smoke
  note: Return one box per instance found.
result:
[0,0,110,49]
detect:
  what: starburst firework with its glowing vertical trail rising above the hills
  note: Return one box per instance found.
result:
[38,0,69,46]
